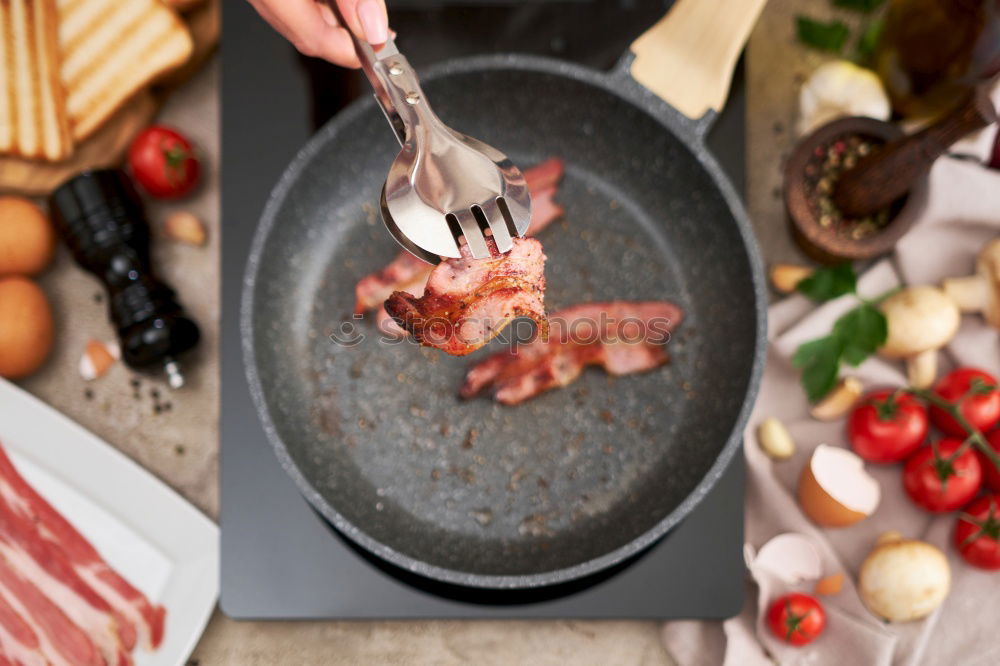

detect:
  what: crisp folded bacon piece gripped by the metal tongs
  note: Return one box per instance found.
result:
[385,238,546,356]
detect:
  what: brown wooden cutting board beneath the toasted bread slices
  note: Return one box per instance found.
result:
[0,0,220,196]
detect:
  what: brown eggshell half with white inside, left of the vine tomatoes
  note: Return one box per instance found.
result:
[798,444,882,527]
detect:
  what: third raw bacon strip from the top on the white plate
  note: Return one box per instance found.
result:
[0,557,104,666]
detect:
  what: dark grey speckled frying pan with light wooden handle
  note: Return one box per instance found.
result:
[241,0,766,588]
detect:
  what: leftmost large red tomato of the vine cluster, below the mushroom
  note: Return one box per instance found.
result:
[847,389,928,463]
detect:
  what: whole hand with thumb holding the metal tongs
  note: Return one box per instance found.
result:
[249,0,389,68]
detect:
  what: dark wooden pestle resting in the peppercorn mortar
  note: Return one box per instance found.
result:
[833,86,997,217]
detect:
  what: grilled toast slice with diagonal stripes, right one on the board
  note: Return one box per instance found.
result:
[57,0,193,141]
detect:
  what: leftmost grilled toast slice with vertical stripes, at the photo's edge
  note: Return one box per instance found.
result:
[0,0,73,162]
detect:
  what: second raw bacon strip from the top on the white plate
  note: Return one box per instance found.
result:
[0,494,136,665]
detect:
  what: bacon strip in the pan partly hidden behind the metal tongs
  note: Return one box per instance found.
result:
[354,157,564,316]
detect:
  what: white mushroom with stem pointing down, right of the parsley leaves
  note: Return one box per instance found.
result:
[879,287,961,388]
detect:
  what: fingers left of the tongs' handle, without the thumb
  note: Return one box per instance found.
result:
[249,0,362,68]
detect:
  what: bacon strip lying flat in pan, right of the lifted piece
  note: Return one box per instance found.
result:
[459,301,682,405]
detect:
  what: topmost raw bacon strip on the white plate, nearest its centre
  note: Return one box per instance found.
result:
[0,448,166,648]
